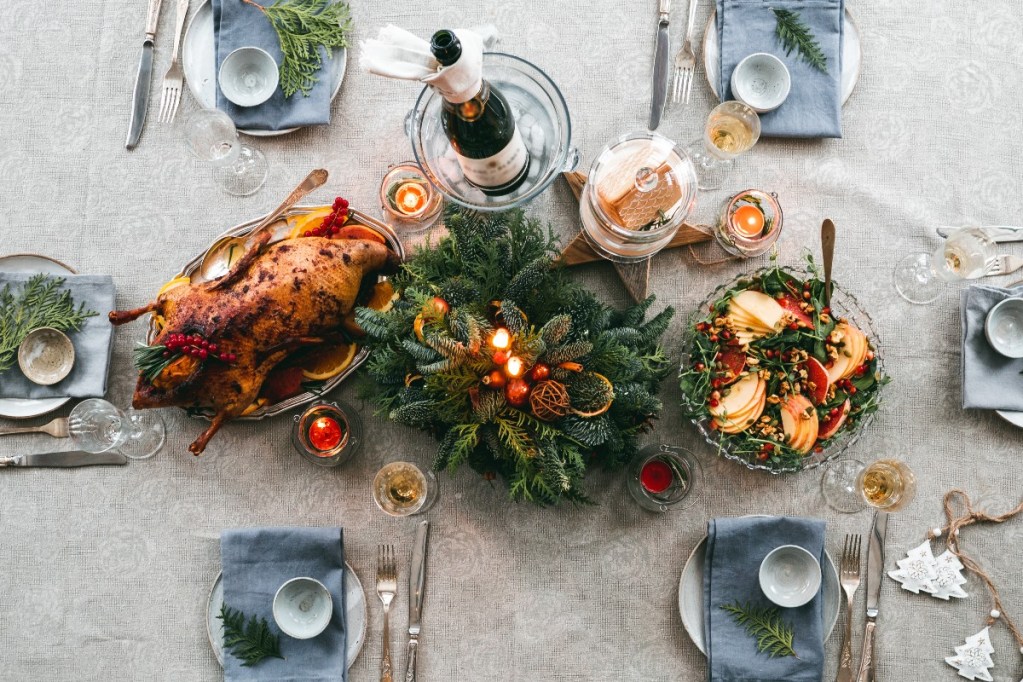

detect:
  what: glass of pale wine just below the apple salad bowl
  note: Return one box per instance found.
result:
[820,459,917,513]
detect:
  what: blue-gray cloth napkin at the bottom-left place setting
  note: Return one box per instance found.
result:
[220,528,348,682]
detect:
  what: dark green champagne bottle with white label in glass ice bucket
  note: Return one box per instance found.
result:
[430,30,530,196]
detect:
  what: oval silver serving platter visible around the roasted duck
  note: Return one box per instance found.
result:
[145,206,405,419]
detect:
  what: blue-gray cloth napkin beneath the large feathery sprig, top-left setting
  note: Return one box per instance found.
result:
[213,0,342,130]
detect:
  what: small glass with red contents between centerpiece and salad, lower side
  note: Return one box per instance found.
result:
[627,445,703,511]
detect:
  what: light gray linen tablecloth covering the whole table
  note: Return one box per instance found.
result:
[0,0,1023,682]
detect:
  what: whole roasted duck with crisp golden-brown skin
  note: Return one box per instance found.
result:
[109,232,398,455]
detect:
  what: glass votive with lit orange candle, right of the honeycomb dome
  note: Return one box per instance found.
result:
[714,189,784,258]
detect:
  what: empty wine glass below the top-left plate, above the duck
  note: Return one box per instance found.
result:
[184,109,267,196]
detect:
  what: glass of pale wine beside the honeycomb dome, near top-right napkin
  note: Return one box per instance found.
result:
[687,100,760,189]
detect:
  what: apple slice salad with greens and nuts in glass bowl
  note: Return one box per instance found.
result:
[680,262,887,471]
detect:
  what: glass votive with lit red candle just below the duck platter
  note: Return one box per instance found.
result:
[292,401,362,467]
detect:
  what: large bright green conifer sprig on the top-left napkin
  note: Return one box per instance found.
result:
[241,0,352,97]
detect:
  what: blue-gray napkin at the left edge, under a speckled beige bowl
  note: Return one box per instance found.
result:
[0,272,114,399]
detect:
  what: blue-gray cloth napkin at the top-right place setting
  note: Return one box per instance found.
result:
[716,0,845,137]
